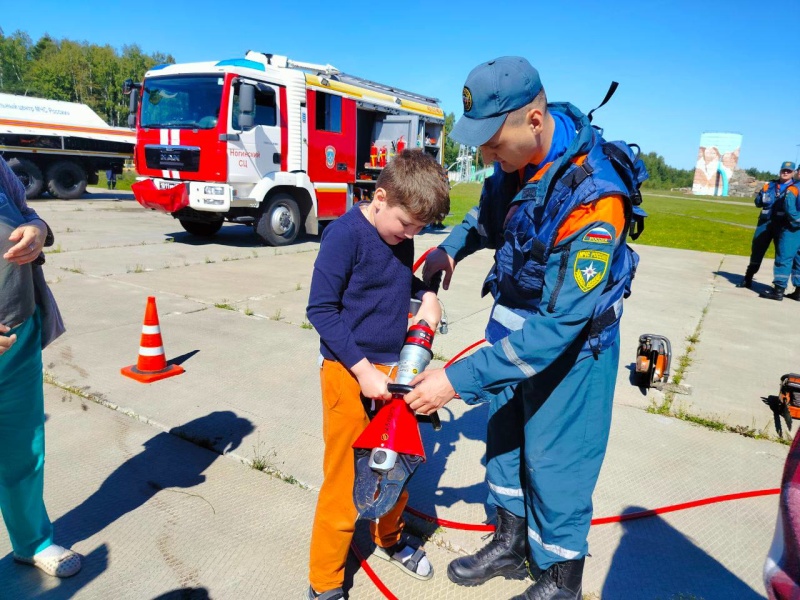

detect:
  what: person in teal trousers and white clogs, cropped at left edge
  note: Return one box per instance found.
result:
[0,158,81,577]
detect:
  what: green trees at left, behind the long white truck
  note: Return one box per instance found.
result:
[0,31,175,126]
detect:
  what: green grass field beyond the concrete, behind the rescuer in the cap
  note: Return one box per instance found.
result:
[445,183,774,257]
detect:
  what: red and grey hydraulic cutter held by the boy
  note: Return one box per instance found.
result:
[353,321,441,520]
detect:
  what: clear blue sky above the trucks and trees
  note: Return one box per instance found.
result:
[6,0,800,172]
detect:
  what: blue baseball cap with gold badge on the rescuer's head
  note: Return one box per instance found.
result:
[450,56,542,146]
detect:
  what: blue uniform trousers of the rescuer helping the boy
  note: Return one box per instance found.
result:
[486,334,619,569]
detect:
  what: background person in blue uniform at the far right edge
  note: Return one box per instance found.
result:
[759,161,800,301]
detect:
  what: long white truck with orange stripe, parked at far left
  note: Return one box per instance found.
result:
[0,94,136,200]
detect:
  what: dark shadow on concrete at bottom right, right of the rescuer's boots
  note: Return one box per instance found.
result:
[600,506,764,600]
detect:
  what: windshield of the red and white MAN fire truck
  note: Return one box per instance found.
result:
[140,75,223,129]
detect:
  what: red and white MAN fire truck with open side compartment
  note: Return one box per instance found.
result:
[125,51,444,246]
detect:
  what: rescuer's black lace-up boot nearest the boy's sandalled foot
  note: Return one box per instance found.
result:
[447,506,528,585]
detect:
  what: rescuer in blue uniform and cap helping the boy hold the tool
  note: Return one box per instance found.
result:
[406,57,644,600]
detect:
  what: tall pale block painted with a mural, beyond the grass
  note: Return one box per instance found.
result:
[692,133,742,196]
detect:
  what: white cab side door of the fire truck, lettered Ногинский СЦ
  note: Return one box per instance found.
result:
[228,83,283,183]
